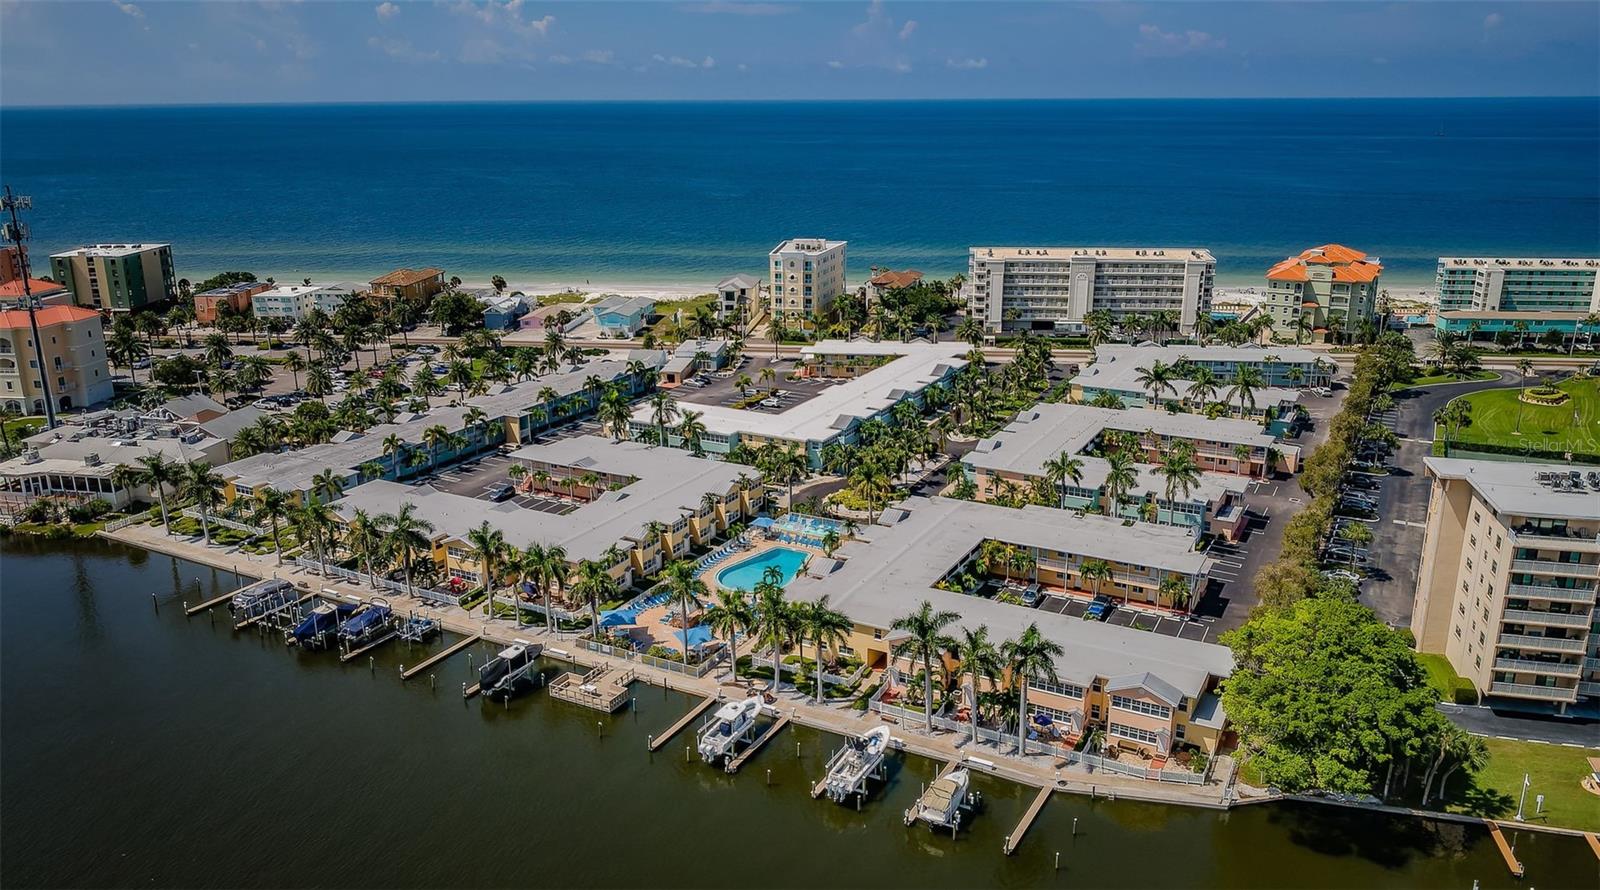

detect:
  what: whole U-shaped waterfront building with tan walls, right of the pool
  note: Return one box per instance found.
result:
[786,498,1234,765]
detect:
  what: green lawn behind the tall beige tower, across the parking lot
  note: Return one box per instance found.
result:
[1434,378,1600,455]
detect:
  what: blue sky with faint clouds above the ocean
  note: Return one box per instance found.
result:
[0,0,1600,106]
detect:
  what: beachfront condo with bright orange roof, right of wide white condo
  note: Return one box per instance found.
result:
[1261,245,1384,335]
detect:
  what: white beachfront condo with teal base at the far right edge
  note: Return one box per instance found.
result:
[1434,256,1600,339]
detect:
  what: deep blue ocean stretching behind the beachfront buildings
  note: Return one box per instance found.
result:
[0,98,1600,287]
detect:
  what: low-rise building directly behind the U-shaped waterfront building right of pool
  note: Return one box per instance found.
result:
[962,403,1277,541]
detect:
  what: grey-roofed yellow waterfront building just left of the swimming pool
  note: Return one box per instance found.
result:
[333,435,762,586]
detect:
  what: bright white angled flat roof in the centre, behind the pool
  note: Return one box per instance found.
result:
[634,341,966,442]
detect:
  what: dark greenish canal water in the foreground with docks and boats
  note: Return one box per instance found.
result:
[0,539,1597,890]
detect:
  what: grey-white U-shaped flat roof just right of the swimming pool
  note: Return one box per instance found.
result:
[786,498,1234,696]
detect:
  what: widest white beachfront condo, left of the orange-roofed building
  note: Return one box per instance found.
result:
[963,247,1216,335]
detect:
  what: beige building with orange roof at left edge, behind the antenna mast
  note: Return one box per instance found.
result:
[0,306,112,415]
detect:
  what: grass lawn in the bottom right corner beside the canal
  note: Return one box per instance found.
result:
[1445,738,1600,831]
